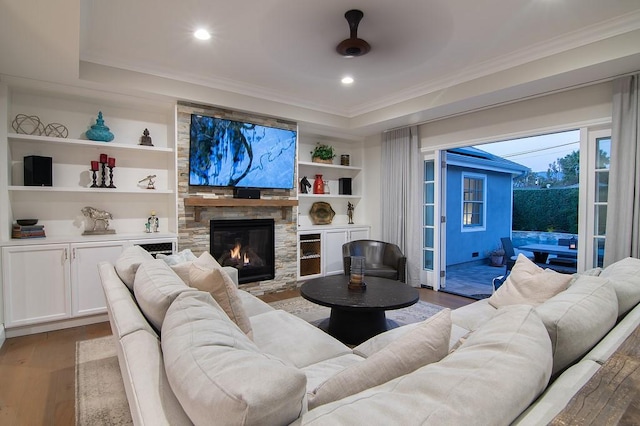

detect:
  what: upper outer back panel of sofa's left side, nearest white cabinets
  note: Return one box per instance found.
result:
[98,262,157,339]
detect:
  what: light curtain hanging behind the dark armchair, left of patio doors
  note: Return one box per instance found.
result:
[380,126,422,287]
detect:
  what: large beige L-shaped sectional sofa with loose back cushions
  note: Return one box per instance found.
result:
[99,247,640,425]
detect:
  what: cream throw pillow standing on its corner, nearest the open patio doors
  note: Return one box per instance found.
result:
[489,254,571,308]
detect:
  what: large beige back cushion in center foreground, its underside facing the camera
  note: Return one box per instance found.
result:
[301,305,552,426]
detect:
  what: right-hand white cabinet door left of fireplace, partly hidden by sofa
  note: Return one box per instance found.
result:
[71,241,124,316]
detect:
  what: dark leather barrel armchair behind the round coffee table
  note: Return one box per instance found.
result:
[342,240,407,283]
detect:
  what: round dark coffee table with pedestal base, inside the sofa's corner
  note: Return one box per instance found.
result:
[300,275,420,345]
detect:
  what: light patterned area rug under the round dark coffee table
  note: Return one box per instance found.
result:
[269,297,444,325]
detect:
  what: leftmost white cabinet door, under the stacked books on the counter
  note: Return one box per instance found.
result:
[2,244,71,328]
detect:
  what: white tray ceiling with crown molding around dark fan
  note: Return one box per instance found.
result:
[0,0,640,134]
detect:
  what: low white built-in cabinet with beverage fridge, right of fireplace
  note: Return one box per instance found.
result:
[298,225,370,279]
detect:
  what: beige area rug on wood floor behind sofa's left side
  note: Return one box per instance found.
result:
[76,336,133,426]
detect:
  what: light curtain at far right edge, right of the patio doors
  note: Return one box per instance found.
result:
[604,74,640,266]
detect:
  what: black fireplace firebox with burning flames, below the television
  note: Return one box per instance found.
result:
[210,219,275,284]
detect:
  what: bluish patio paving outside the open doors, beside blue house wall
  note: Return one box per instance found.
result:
[440,263,505,299]
